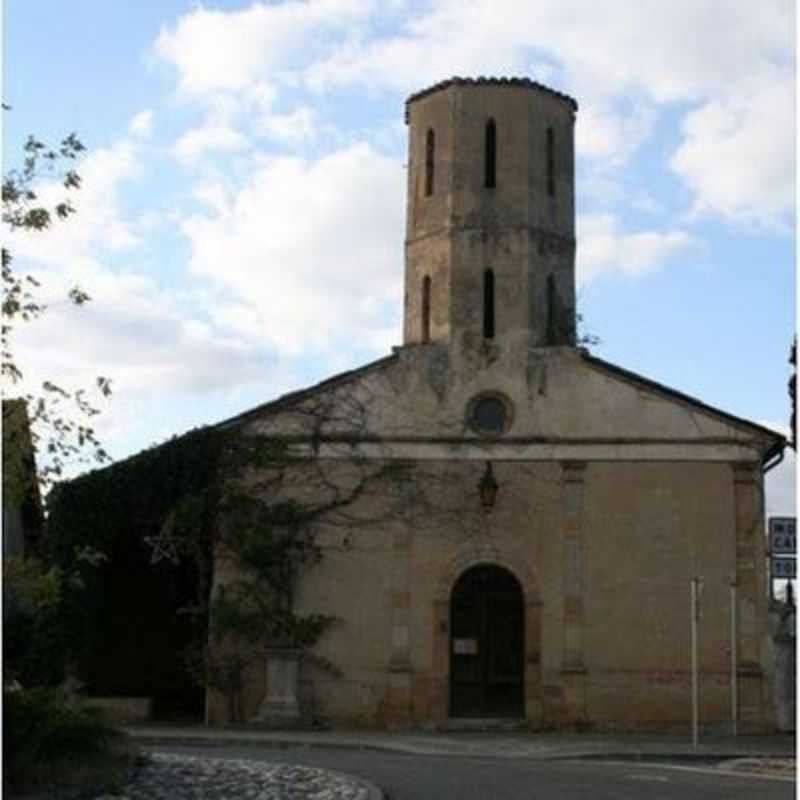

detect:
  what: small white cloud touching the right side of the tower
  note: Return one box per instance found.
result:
[577,214,698,285]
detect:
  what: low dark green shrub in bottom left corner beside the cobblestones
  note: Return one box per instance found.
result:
[3,689,130,789]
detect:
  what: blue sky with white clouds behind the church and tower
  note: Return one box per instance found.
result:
[3,0,795,513]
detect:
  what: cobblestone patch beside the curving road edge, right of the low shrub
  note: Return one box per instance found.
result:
[96,753,382,800]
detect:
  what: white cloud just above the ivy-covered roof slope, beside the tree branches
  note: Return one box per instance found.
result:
[9,270,275,473]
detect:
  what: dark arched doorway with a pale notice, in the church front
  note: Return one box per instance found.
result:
[450,564,525,717]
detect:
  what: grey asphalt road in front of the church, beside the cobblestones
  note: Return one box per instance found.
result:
[150,746,796,800]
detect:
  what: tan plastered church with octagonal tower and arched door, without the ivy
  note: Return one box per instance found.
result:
[207,78,784,731]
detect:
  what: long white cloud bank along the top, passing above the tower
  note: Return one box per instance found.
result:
[154,0,794,224]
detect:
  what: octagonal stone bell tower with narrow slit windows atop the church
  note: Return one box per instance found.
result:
[404,78,577,350]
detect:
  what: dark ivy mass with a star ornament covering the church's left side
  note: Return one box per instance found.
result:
[46,429,222,716]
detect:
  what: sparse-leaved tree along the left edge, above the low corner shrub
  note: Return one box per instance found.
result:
[1,133,110,685]
